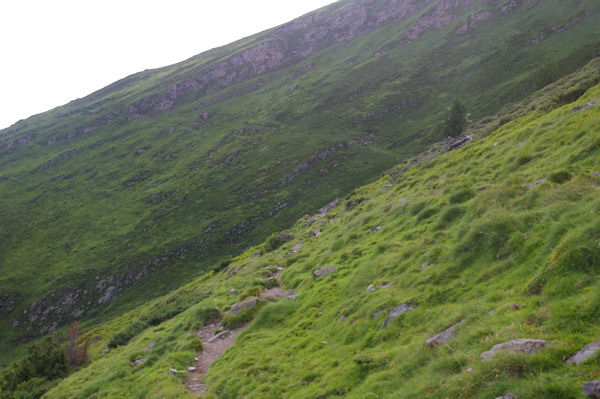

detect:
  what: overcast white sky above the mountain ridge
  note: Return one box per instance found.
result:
[0,0,334,129]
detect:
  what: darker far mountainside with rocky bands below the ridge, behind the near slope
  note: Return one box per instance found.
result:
[0,0,600,360]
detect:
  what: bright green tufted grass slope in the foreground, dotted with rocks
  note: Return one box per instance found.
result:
[31,59,600,399]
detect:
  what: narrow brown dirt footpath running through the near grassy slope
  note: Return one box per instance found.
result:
[183,268,294,396]
